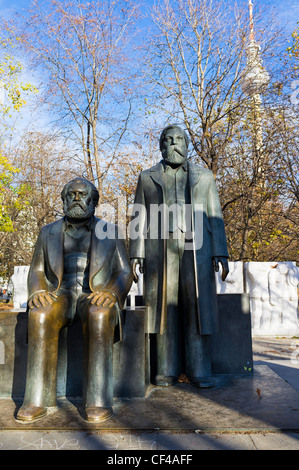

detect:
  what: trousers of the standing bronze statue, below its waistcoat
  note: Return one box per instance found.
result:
[155,232,212,378]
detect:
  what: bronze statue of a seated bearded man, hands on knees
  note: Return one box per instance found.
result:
[17,178,133,422]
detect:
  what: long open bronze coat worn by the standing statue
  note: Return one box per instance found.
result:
[130,162,228,334]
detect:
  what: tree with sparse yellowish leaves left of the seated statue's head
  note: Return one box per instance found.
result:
[0,131,76,277]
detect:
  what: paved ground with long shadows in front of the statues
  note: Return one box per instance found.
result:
[0,337,299,450]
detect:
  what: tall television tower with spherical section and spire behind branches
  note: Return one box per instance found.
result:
[243,0,270,176]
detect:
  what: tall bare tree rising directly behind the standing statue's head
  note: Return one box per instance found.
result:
[148,0,282,175]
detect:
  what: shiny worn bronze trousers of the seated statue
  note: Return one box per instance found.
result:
[23,289,117,407]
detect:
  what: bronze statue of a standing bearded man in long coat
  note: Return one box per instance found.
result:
[130,125,228,387]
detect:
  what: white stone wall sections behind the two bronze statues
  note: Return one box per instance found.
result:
[12,261,299,336]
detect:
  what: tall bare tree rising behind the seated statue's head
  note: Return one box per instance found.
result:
[7,0,137,202]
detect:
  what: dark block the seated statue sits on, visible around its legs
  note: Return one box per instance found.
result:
[0,307,149,398]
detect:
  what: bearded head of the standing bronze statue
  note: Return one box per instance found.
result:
[160,124,188,165]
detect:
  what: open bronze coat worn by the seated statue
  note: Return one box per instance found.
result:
[28,217,133,338]
